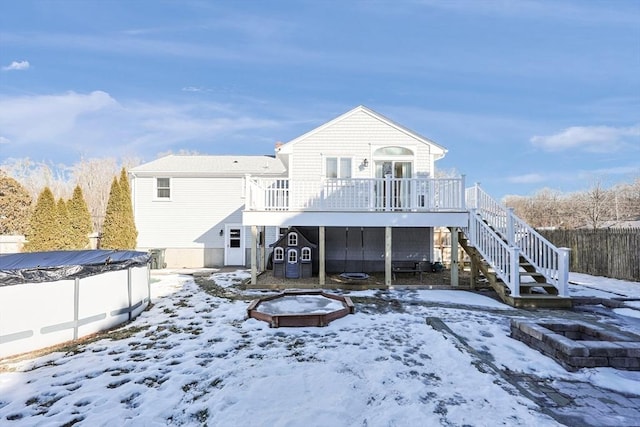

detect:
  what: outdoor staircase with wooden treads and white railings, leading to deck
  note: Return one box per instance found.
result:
[458,187,572,308]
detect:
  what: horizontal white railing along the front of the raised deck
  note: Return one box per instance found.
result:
[245,176,465,212]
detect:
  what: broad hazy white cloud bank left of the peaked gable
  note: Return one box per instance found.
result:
[0,91,291,164]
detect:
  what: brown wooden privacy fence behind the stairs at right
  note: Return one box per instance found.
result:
[538,228,640,282]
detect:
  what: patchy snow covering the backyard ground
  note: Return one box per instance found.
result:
[0,271,640,427]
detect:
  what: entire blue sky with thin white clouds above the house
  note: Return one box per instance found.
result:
[0,0,640,198]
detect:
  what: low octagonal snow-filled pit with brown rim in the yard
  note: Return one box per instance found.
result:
[247,290,355,328]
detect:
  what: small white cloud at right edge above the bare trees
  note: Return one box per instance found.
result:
[530,125,640,152]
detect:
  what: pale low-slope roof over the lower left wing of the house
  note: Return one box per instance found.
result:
[129,154,285,177]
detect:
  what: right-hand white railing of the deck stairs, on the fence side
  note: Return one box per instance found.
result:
[466,184,570,297]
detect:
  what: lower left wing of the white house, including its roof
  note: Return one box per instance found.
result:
[129,155,285,268]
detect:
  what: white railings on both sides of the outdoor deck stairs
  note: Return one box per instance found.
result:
[466,185,569,297]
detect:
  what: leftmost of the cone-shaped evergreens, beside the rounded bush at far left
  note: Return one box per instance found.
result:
[24,187,59,252]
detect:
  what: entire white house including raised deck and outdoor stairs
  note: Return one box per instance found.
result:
[131,106,568,308]
